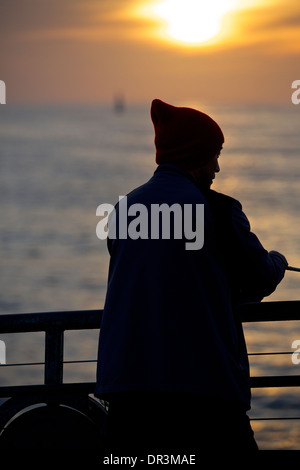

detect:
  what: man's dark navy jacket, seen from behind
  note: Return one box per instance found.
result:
[96,164,284,409]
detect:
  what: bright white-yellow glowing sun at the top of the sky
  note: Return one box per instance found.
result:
[152,0,236,44]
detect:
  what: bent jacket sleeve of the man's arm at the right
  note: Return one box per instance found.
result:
[231,201,288,301]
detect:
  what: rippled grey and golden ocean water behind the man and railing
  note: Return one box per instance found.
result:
[0,103,300,449]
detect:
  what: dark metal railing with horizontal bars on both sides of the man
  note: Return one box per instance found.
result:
[0,301,300,397]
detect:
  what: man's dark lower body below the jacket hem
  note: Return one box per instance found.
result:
[108,393,258,459]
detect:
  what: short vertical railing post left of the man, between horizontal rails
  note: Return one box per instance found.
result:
[45,329,64,385]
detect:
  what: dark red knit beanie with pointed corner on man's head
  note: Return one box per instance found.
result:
[151,99,224,170]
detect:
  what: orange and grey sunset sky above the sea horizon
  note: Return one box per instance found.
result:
[0,0,300,105]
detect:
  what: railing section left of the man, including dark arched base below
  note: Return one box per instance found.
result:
[0,310,107,455]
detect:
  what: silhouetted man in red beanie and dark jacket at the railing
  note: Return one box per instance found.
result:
[96,100,287,459]
